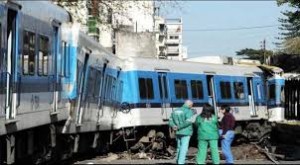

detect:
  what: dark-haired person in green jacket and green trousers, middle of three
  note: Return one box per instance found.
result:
[195,104,220,164]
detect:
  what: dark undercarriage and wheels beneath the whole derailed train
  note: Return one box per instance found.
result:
[0,120,272,164]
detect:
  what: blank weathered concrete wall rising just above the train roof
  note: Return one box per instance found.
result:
[116,31,156,58]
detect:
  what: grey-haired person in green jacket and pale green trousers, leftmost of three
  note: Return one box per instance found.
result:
[169,100,194,164]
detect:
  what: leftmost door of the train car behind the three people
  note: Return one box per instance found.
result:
[158,72,171,120]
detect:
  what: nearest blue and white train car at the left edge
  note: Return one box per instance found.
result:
[0,1,71,164]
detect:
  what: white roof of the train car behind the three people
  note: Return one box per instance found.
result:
[124,57,263,76]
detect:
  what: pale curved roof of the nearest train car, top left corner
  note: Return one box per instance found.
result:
[3,0,71,22]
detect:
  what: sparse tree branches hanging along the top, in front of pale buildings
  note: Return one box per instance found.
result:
[52,0,180,24]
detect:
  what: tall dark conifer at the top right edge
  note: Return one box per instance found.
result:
[277,0,300,54]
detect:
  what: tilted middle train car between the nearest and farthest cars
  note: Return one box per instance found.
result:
[61,23,124,154]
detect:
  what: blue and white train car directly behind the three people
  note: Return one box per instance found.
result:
[109,58,284,142]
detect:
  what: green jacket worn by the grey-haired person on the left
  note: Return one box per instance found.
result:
[169,105,193,135]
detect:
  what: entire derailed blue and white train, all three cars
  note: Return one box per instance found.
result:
[0,1,284,164]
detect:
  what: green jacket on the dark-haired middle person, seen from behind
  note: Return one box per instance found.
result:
[195,115,219,140]
